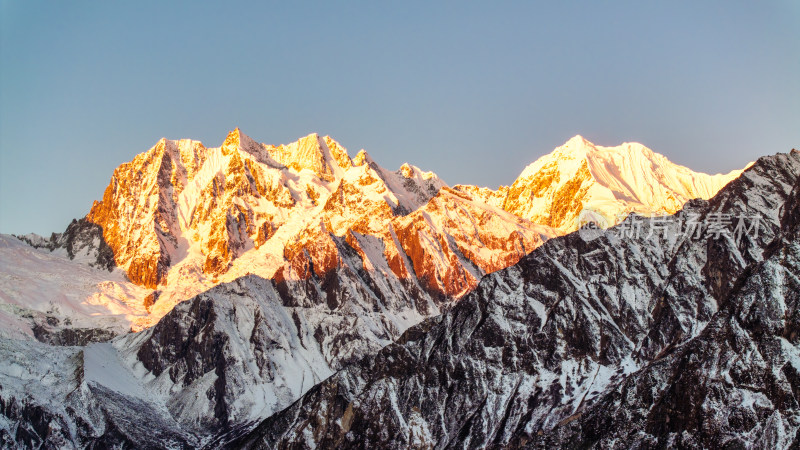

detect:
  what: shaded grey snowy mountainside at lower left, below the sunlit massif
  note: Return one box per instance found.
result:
[0,237,439,447]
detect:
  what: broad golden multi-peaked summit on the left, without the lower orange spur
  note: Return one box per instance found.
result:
[51,127,468,320]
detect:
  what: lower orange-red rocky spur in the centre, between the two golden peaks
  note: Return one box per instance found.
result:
[277,180,555,304]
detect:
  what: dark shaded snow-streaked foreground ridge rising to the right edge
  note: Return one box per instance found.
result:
[236,151,800,448]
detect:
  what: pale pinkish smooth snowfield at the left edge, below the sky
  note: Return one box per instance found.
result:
[0,234,150,345]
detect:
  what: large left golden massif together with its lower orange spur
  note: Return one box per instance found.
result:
[45,128,532,328]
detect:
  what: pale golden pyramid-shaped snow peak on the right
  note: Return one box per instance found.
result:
[456,136,742,233]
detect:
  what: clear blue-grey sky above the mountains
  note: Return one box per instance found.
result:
[0,0,800,234]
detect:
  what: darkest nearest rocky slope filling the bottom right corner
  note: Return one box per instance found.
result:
[532,218,800,448]
